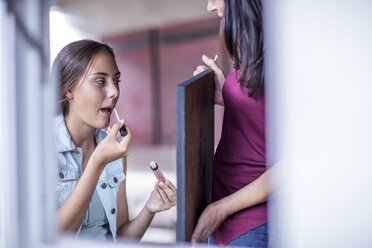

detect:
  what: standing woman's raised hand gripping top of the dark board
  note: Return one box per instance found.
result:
[193,55,226,105]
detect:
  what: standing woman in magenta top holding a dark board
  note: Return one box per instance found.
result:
[192,0,271,247]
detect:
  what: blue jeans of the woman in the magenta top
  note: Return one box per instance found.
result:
[208,223,269,247]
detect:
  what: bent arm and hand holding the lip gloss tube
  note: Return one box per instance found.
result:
[117,158,177,239]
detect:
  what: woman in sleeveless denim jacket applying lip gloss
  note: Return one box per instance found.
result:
[53,40,177,240]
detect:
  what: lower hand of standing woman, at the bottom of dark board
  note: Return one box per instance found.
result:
[191,200,229,244]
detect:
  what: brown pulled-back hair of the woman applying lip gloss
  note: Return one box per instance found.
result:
[52,40,115,116]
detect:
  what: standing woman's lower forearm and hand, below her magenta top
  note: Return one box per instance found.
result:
[191,168,273,243]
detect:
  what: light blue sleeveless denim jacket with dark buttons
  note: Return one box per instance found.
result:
[54,115,125,240]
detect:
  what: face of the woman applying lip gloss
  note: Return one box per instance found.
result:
[67,52,120,128]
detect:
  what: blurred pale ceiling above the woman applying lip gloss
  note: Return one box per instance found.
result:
[52,0,215,37]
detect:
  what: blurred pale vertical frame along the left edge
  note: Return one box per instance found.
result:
[0,0,56,247]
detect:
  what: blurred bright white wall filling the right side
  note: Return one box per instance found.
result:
[266,0,372,248]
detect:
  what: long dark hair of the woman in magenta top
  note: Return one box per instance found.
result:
[224,0,264,97]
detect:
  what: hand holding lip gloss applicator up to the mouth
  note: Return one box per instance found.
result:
[92,122,132,165]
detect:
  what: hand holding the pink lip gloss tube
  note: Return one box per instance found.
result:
[146,180,177,213]
